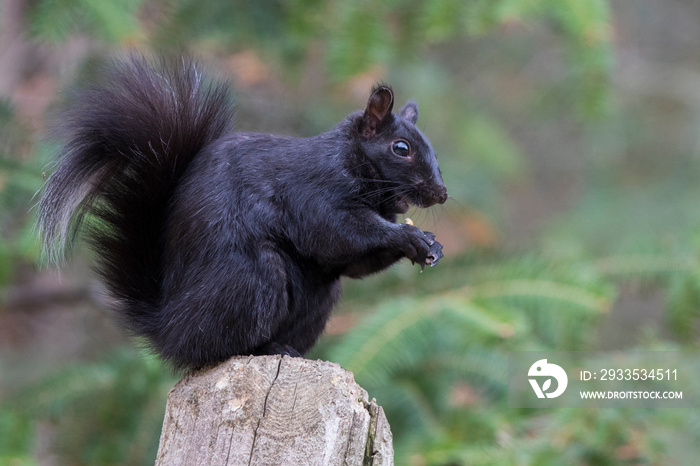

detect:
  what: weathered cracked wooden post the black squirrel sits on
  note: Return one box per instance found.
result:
[156,356,394,466]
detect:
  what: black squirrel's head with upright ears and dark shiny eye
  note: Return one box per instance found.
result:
[357,85,447,213]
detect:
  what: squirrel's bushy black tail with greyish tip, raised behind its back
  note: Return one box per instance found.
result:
[39,56,233,336]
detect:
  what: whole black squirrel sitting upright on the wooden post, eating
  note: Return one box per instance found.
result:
[39,56,448,367]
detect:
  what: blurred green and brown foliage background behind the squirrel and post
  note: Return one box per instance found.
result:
[0,0,700,466]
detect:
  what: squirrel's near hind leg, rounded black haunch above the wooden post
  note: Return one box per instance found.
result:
[157,242,292,367]
